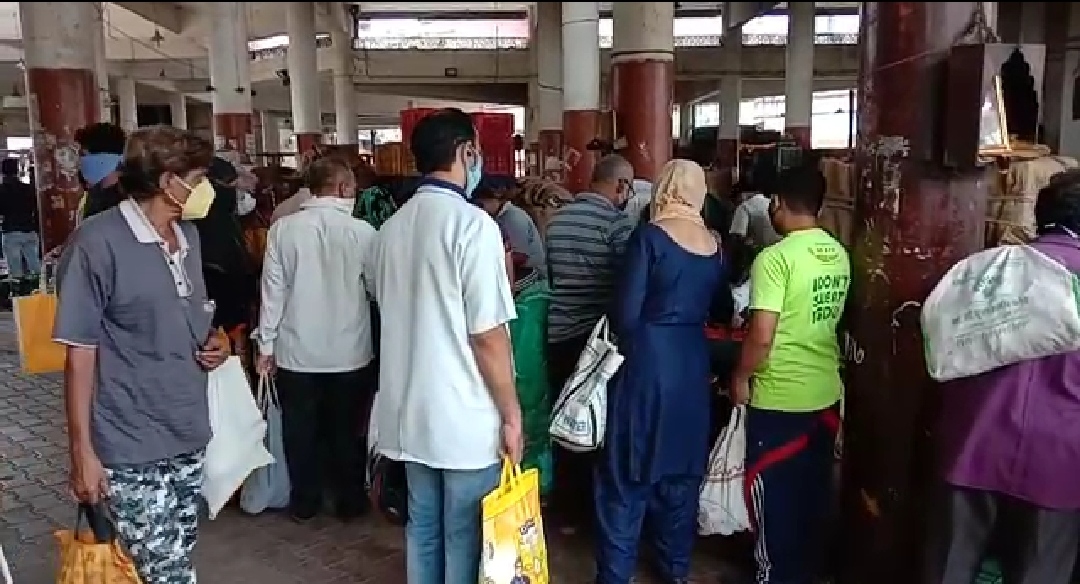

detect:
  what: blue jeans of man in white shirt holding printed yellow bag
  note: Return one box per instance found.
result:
[405,462,502,584]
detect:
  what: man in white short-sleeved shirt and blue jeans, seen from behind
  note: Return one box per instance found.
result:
[365,109,523,584]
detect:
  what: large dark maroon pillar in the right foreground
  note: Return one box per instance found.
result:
[839,2,987,584]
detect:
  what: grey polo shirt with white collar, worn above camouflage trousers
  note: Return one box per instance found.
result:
[53,200,214,466]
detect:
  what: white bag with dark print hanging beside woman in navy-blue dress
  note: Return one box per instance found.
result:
[550,316,623,452]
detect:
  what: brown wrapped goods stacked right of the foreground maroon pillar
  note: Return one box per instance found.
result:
[986,146,1077,246]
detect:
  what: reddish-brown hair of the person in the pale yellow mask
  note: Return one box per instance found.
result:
[120,125,214,200]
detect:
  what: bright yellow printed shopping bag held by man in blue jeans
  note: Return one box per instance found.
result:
[480,459,549,584]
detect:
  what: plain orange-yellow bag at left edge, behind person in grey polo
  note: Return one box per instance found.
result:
[13,291,67,374]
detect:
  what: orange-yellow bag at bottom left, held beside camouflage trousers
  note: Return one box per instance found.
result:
[56,508,141,584]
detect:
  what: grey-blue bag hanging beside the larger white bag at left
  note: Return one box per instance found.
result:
[240,375,291,515]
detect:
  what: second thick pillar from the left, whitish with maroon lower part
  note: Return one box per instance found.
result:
[206,2,255,152]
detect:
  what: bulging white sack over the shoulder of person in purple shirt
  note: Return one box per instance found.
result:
[922,245,1080,381]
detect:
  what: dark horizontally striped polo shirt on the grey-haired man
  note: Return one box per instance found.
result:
[546,192,634,342]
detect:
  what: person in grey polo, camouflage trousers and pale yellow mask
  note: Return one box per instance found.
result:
[54,126,228,583]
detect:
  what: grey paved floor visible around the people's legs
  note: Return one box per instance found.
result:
[0,315,747,584]
